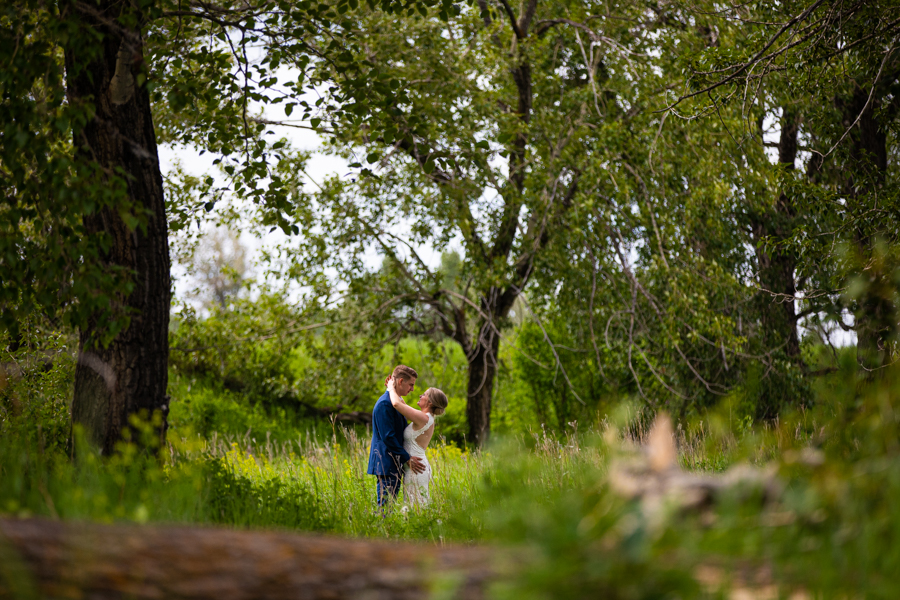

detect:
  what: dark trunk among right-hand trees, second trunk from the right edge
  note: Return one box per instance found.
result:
[753,108,800,361]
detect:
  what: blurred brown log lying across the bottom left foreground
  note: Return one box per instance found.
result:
[0,519,492,600]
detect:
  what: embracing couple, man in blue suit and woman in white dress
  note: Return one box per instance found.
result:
[368,365,448,508]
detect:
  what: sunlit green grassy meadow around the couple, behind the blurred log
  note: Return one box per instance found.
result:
[0,326,900,598]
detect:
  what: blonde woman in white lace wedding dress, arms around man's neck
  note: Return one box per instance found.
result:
[388,377,448,506]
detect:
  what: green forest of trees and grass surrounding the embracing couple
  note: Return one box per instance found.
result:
[0,0,900,595]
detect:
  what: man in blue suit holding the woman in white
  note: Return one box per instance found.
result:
[368,365,425,507]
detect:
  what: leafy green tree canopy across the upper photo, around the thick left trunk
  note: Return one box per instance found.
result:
[7,0,900,442]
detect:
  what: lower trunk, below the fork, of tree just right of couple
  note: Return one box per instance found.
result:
[466,323,500,446]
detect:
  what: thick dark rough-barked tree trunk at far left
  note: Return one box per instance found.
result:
[64,0,170,453]
